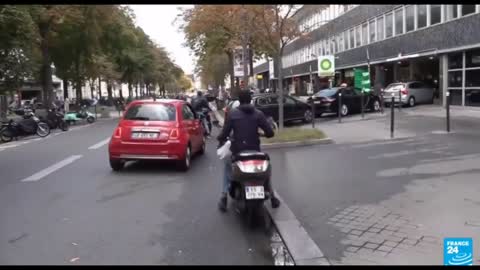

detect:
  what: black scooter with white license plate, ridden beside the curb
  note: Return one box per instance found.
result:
[229,151,271,227]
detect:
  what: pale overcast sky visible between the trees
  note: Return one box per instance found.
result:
[130,5,195,74]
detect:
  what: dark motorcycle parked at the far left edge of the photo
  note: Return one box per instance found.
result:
[0,111,50,142]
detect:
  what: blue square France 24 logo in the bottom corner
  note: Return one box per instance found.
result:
[443,238,473,265]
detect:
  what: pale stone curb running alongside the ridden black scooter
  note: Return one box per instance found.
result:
[266,194,331,265]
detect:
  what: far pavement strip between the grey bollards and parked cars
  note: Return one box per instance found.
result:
[303,105,480,143]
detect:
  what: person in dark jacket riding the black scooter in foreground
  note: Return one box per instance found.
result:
[217,91,280,211]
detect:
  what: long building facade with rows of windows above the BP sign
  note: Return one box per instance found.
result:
[254,5,480,106]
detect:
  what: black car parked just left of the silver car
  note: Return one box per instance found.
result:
[308,87,380,116]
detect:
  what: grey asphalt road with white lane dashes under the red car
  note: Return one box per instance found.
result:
[0,120,273,265]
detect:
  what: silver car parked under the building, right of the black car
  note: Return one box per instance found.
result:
[383,81,435,107]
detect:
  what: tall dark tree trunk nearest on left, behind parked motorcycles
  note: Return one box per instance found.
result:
[39,23,53,108]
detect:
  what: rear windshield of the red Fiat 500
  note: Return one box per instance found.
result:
[124,104,177,121]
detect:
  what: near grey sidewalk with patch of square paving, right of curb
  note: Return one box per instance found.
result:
[270,133,480,265]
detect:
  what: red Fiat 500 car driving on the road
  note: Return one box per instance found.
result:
[108,99,206,171]
